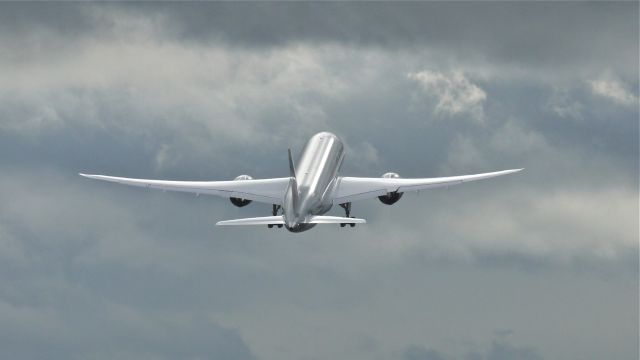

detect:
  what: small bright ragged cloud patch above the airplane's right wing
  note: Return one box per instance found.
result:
[407,70,487,121]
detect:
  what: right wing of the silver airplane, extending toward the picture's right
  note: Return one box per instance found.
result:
[333,169,522,204]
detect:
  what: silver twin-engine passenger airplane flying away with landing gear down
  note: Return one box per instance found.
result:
[79,132,523,233]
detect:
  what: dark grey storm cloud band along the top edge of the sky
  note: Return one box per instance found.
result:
[129,2,638,64]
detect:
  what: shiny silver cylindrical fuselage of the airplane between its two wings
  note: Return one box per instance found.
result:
[282,132,344,232]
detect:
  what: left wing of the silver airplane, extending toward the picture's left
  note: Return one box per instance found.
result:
[80,174,290,205]
